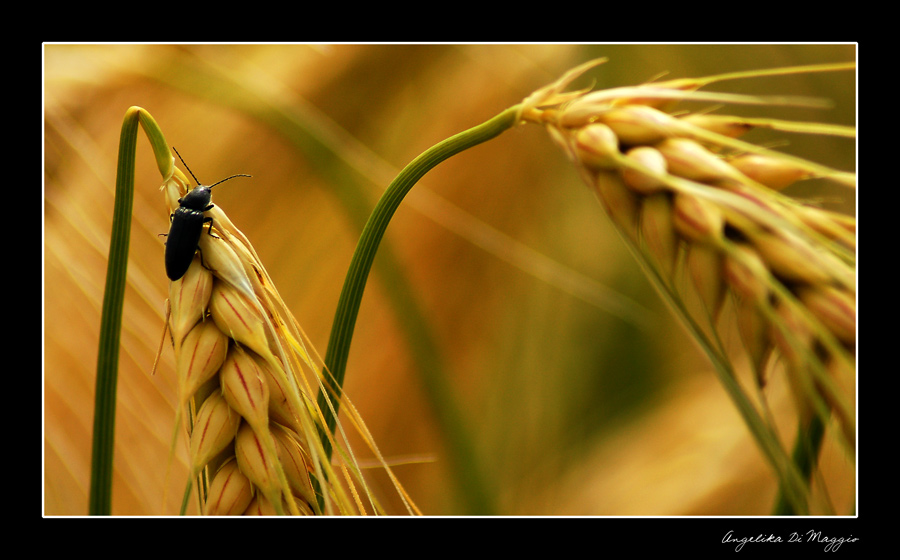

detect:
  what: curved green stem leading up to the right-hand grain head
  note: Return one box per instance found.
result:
[318,106,519,450]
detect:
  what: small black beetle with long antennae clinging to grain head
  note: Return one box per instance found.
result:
[166,148,250,281]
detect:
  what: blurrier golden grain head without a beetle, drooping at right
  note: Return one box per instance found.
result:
[521,60,856,462]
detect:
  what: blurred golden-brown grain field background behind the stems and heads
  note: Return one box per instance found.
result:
[43,44,856,516]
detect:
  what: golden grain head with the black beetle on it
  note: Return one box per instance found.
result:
[162,163,378,515]
